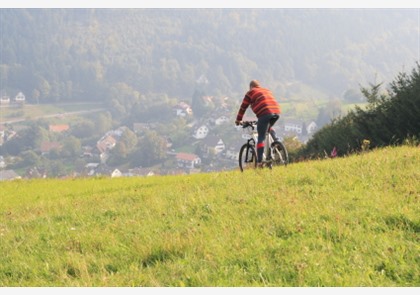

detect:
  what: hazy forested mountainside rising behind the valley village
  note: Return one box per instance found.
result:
[0,9,418,102]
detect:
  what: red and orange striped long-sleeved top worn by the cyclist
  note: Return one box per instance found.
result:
[236,86,281,121]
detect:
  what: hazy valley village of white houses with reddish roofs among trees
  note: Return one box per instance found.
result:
[0,92,317,180]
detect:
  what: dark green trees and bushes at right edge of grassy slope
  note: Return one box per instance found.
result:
[299,63,420,158]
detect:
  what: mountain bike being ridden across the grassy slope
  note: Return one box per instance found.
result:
[239,121,289,172]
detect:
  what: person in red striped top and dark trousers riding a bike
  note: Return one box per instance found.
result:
[235,80,281,168]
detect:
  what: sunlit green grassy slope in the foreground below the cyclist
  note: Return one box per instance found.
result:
[0,146,420,286]
